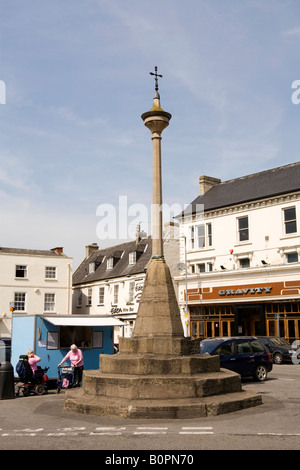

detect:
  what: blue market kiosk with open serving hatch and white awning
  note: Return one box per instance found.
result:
[11,314,124,379]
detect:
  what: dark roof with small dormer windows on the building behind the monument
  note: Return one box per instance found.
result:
[73,236,152,286]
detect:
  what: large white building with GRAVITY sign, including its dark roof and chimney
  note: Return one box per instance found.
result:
[176,162,300,341]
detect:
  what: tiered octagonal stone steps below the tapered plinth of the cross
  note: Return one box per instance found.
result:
[65,354,262,419]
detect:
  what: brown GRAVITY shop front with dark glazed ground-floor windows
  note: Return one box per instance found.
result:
[188,281,300,342]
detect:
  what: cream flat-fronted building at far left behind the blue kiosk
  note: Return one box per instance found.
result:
[0,247,72,337]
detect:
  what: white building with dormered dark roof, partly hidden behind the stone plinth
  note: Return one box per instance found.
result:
[72,223,179,343]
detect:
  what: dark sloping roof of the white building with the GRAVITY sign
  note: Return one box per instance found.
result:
[178,162,300,217]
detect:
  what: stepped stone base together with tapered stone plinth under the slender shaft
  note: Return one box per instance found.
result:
[65,259,262,419]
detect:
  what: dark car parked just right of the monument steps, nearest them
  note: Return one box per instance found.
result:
[200,336,273,381]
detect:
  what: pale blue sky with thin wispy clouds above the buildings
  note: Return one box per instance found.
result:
[0,0,300,269]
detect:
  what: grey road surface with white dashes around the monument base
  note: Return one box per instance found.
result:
[0,364,300,455]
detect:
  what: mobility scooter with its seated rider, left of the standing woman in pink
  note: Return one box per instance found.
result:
[15,355,49,397]
